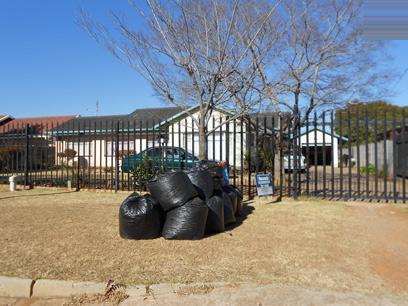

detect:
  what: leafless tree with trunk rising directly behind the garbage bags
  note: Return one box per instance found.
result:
[80,0,280,159]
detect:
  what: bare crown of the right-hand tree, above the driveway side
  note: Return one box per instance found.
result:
[251,0,395,127]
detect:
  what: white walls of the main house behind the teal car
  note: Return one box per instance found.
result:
[55,111,246,168]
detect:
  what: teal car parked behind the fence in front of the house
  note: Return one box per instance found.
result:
[121,147,207,172]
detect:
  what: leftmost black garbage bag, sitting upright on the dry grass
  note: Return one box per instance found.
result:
[119,193,164,239]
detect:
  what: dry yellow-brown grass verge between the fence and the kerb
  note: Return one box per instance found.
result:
[0,189,408,293]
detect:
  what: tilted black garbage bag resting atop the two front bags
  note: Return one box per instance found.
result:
[147,171,197,211]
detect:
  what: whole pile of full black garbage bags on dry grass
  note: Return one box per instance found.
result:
[119,165,242,240]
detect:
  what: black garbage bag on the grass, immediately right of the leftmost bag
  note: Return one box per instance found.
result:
[162,197,208,240]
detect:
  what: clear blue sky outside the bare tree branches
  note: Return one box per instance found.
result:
[0,0,408,117]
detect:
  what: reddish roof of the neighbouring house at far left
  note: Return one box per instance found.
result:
[0,115,75,134]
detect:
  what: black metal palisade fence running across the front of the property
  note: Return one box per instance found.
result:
[0,110,408,203]
